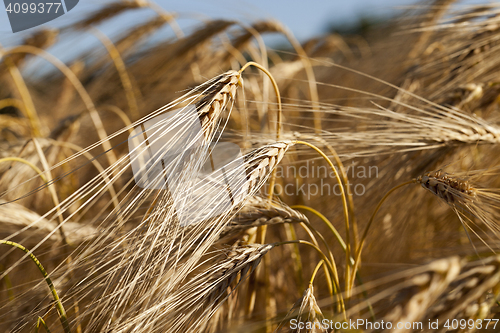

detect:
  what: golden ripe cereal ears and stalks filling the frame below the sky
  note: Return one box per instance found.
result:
[0,0,500,333]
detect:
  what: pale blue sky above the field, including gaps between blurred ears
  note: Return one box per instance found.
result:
[0,0,491,68]
